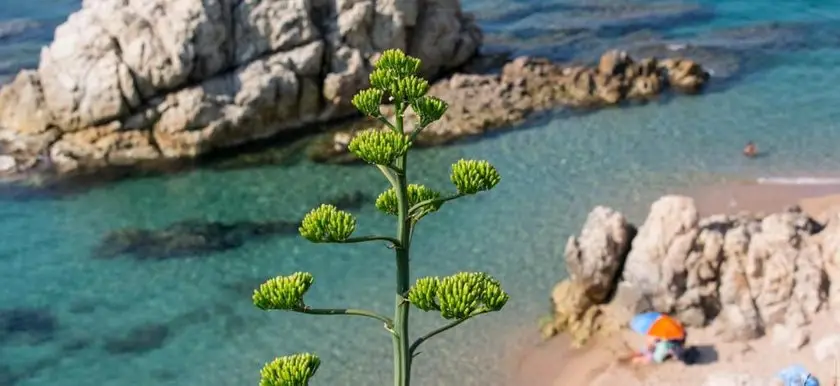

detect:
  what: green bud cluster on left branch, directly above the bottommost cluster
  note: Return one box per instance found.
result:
[252,272,315,310]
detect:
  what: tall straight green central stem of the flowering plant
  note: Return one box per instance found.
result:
[394,103,412,386]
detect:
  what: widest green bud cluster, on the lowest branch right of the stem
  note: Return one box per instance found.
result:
[408,272,510,319]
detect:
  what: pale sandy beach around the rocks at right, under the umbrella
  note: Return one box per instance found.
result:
[511,183,840,386]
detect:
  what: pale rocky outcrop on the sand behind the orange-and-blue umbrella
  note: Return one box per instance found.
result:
[547,196,840,350]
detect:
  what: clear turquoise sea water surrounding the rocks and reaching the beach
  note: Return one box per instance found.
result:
[0,0,840,386]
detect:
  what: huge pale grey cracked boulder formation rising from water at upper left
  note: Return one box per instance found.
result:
[0,0,481,177]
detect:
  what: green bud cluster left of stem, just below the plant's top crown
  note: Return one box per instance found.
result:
[347,129,411,165]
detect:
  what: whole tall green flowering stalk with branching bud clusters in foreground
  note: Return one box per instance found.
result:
[253,50,509,386]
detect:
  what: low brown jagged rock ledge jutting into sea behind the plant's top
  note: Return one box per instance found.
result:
[309,50,709,163]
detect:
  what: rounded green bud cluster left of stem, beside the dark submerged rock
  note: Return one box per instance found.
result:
[298,204,356,243]
